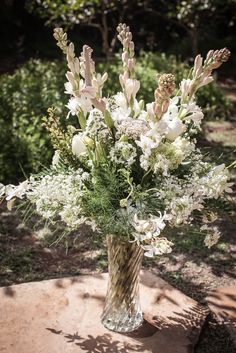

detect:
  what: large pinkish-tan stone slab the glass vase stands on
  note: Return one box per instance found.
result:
[0,271,207,353]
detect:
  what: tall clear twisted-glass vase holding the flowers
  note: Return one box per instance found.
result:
[102,235,143,332]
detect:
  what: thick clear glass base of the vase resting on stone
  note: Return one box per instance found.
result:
[102,313,143,333]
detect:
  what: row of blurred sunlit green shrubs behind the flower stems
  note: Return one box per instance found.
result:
[0,52,230,183]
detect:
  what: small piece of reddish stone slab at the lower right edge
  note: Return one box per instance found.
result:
[207,285,236,345]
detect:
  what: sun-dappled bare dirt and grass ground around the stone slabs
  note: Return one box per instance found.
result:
[0,81,236,353]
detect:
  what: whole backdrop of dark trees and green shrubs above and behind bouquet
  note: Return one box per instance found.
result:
[0,0,236,183]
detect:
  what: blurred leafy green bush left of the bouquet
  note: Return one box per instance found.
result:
[0,60,66,183]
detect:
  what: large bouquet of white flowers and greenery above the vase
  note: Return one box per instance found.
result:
[0,24,231,256]
